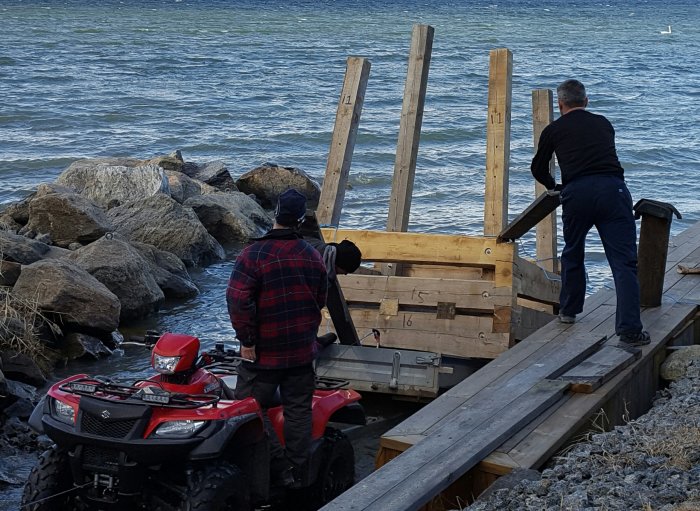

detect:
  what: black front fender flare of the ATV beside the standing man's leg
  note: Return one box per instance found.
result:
[190,413,265,461]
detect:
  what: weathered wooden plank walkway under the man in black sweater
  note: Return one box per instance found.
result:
[323,223,700,511]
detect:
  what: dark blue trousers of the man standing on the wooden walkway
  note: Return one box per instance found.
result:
[559,174,642,335]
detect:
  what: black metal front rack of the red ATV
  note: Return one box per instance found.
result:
[59,378,220,408]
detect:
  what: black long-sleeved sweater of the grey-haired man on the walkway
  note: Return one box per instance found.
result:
[530,110,624,190]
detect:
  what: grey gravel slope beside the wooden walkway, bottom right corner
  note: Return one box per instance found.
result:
[467,366,700,511]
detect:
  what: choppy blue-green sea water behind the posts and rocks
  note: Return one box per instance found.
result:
[0,0,700,367]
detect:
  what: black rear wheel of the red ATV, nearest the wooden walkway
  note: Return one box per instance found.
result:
[309,428,355,509]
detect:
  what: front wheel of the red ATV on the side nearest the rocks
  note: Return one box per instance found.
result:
[20,446,83,511]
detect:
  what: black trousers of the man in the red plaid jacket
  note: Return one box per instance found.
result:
[235,363,316,470]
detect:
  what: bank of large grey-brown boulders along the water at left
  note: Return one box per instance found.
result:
[0,151,321,500]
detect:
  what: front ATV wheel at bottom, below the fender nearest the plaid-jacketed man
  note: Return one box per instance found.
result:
[180,461,250,511]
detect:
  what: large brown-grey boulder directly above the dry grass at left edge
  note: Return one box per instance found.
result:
[12,259,121,333]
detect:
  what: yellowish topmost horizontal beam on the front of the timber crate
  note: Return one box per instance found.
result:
[322,228,517,268]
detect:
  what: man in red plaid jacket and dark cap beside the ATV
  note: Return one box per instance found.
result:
[226,189,328,487]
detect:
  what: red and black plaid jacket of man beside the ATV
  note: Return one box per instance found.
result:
[226,229,328,369]
